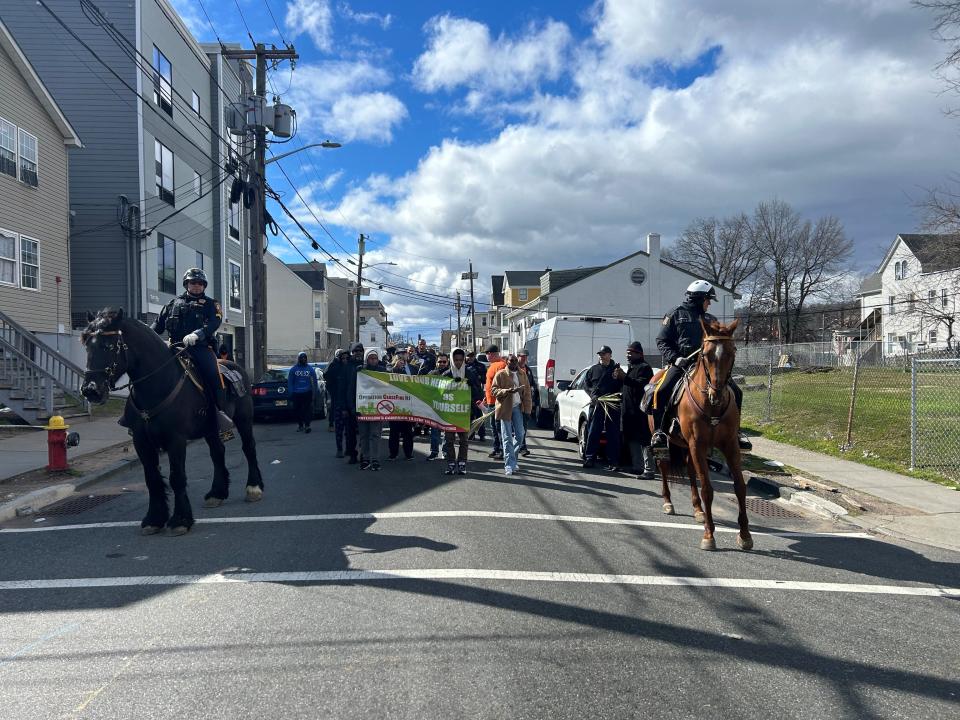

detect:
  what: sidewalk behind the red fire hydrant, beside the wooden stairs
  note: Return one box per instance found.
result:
[0,417,130,482]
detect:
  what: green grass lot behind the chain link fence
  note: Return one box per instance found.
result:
[743,368,960,487]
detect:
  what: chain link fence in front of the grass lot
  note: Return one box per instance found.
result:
[734,338,960,480]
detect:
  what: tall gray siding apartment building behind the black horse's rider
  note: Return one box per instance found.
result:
[0,0,250,360]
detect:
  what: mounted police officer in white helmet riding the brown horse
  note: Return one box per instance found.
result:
[650,280,753,450]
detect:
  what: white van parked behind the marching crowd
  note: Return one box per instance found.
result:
[523,315,633,428]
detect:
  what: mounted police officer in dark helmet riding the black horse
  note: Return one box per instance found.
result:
[153,268,233,435]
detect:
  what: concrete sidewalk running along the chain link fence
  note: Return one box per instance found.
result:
[750,437,960,550]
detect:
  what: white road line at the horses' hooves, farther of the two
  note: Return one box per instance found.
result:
[0,510,873,540]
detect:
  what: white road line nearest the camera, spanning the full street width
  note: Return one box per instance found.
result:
[0,568,960,598]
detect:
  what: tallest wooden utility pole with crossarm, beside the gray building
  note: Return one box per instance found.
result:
[222,43,300,378]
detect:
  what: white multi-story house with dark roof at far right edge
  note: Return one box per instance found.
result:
[859,234,960,356]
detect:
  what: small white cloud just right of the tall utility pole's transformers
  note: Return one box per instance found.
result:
[288,60,407,143]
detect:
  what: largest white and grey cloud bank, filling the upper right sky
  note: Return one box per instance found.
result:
[328,0,956,334]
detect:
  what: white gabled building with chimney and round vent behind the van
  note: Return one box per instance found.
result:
[506,233,736,361]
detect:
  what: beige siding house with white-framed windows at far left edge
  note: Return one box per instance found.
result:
[0,21,81,352]
